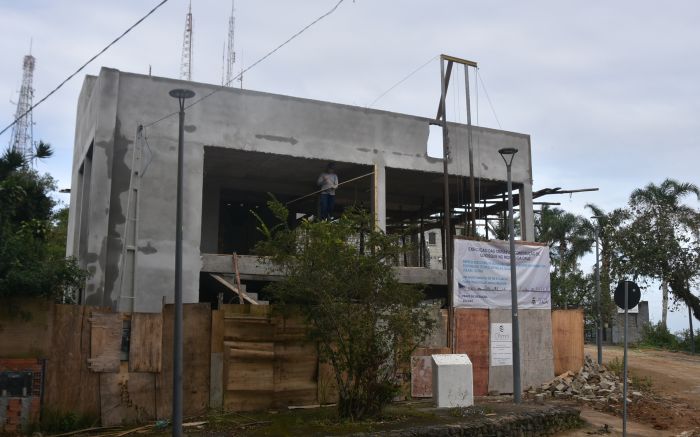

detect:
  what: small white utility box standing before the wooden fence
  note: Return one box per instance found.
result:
[432,354,474,408]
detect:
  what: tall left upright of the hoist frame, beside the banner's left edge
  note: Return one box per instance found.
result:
[440,59,455,352]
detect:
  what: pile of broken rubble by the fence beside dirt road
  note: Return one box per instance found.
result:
[528,355,644,408]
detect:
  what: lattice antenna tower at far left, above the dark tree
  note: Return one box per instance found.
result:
[10,47,36,159]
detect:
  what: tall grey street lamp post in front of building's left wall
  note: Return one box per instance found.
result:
[169,89,194,437]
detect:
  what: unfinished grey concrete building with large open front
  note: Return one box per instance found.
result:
[68,68,534,312]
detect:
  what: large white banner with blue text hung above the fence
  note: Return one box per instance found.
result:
[453,239,551,309]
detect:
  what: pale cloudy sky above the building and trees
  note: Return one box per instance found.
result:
[0,0,700,330]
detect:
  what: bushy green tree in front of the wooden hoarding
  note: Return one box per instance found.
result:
[256,199,433,419]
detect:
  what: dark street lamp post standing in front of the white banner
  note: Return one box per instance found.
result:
[498,147,522,404]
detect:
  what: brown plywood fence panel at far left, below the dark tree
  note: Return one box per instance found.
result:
[0,299,54,358]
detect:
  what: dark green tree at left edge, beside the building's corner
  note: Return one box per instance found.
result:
[0,142,85,298]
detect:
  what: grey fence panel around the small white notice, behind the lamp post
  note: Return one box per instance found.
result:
[489,309,554,393]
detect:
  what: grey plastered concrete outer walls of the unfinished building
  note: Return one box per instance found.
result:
[67,68,534,312]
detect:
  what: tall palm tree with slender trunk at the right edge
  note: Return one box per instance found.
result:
[629,179,700,327]
